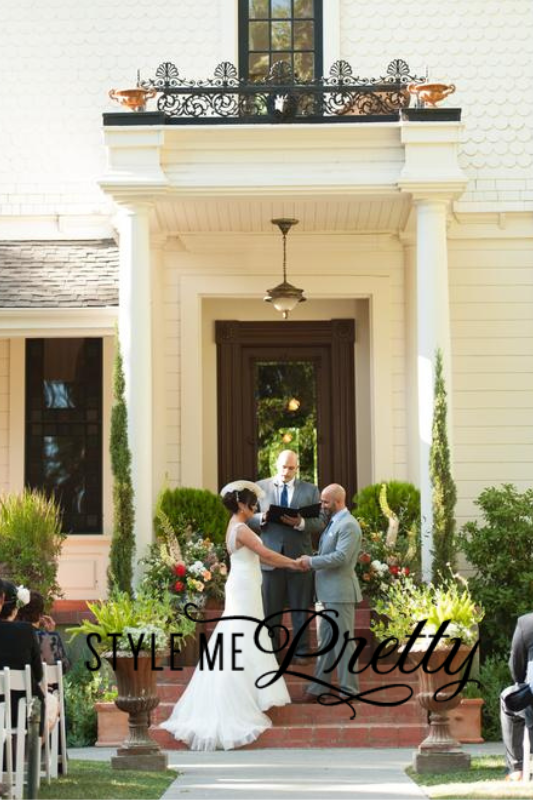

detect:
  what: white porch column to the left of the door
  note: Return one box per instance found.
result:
[119,203,153,581]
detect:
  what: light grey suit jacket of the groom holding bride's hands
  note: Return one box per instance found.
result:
[311,508,363,603]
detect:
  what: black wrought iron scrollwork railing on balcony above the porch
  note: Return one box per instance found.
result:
[140,59,424,124]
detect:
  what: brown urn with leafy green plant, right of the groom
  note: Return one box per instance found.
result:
[372,576,483,772]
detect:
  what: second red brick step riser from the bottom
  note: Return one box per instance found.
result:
[152,701,426,726]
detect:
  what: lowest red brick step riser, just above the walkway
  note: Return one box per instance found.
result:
[150,724,427,750]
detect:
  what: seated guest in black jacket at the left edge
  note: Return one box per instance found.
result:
[0,580,44,725]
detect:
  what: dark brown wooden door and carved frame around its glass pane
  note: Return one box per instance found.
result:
[216,319,357,498]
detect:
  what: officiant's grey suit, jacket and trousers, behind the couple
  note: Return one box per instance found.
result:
[248,477,325,655]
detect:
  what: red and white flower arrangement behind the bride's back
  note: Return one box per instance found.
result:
[142,509,228,608]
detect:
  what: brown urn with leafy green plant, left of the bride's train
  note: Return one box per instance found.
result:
[69,592,195,769]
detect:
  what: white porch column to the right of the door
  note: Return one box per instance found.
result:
[416,197,451,580]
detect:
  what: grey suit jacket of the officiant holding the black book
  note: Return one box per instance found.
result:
[248,478,325,570]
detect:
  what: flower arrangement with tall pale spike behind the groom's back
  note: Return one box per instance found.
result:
[356,483,418,603]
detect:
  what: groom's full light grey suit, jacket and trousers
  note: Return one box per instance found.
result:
[307,508,362,695]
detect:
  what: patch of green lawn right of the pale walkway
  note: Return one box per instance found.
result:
[407,756,533,800]
